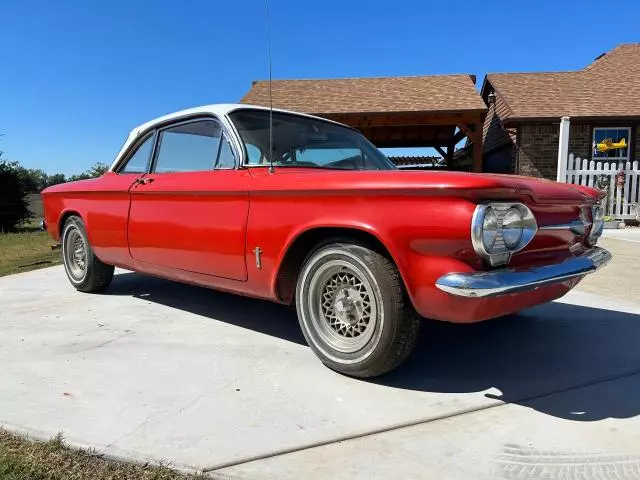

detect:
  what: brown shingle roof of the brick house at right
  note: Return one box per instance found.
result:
[487,43,640,123]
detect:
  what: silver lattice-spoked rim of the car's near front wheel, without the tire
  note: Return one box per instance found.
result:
[309,260,378,353]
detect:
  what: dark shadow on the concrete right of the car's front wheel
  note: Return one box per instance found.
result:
[373,302,640,421]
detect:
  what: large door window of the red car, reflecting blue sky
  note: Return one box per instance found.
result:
[154,120,222,173]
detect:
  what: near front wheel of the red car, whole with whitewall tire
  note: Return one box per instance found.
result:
[296,243,420,378]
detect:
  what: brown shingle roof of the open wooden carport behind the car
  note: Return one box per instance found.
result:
[241,75,486,115]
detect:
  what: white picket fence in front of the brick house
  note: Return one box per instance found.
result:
[560,153,640,219]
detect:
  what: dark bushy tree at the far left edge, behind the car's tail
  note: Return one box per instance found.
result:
[0,160,33,232]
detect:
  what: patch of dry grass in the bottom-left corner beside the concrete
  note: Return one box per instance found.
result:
[0,429,208,480]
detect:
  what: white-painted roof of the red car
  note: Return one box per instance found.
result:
[109,103,351,171]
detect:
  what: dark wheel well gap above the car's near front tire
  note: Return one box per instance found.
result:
[276,227,395,304]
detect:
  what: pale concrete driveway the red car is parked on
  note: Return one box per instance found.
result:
[0,234,640,479]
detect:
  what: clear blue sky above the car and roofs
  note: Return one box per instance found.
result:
[0,0,640,174]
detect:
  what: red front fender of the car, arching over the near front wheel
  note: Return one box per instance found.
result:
[247,193,480,315]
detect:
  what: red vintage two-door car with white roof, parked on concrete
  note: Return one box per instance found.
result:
[43,105,611,377]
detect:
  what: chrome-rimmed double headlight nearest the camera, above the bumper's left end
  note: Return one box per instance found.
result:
[471,203,538,266]
